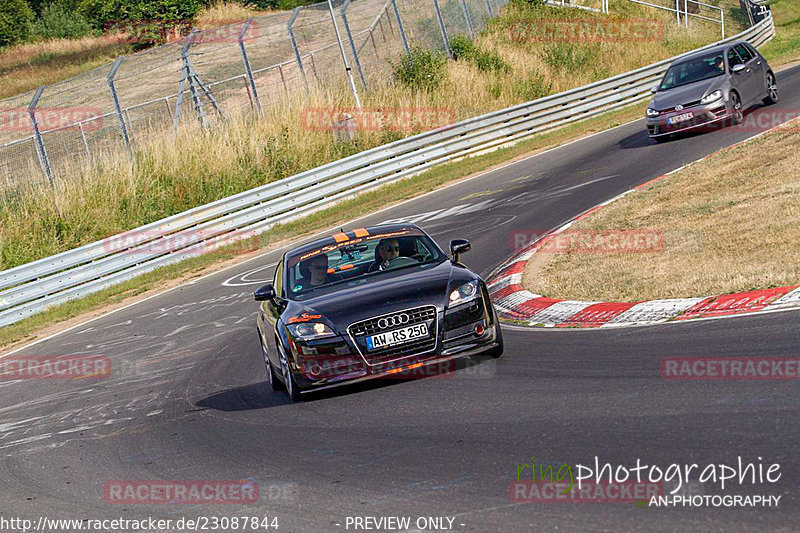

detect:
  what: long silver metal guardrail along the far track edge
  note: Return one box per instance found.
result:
[0,17,775,326]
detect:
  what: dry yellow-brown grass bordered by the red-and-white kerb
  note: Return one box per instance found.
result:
[523,121,800,301]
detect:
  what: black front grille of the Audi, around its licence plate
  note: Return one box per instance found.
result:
[347,305,438,366]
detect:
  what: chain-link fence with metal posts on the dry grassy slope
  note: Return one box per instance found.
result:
[0,0,507,187]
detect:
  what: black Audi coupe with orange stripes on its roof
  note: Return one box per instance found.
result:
[254,224,503,400]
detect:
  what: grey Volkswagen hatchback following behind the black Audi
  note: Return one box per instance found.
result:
[646,41,778,141]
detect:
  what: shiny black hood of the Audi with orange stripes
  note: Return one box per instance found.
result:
[283,261,477,332]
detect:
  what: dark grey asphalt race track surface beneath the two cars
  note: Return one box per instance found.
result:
[0,64,800,532]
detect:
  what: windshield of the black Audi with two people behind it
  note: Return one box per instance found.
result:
[286,230,447,300]
